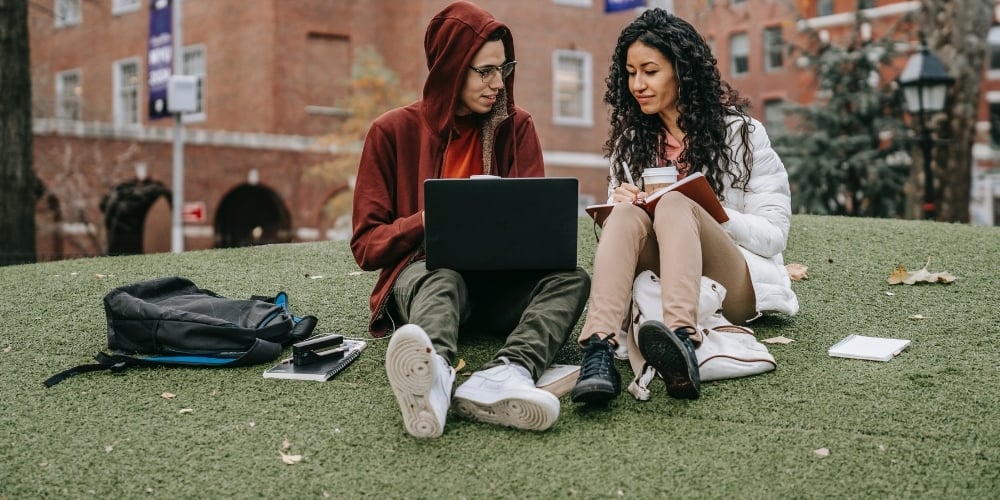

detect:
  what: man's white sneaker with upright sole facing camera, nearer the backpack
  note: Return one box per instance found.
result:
[385,324,455,438]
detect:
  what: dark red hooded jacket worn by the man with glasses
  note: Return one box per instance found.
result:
[351,1,545,337]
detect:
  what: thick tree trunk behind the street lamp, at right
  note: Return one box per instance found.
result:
[914,0,993,222]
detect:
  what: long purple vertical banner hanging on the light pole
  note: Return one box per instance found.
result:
[146,0,174,120]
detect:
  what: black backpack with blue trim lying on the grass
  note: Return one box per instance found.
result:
[45,276,316,387]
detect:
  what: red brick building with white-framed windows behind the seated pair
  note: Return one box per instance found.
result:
[29,0,1000,260]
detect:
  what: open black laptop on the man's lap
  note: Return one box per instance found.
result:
[424,177,580,271]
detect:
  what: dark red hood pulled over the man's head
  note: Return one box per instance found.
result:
[423,1,516,137]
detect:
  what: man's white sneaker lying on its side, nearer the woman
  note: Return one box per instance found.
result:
[455,364,559,431]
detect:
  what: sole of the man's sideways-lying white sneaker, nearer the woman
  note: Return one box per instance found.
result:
[454,387,559,431]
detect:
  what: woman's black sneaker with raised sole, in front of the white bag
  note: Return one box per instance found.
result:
[636,321,701,399]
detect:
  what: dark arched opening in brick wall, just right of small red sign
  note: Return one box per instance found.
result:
[215,184,292,248]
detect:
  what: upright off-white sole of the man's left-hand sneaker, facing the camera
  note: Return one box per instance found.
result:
[385,330,444,438]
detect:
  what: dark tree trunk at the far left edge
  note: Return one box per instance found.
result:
[0,0,36,265]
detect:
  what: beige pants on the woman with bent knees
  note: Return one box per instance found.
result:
[578,189,756,345]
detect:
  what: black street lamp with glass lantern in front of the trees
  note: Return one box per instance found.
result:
[897,37,955,219]
